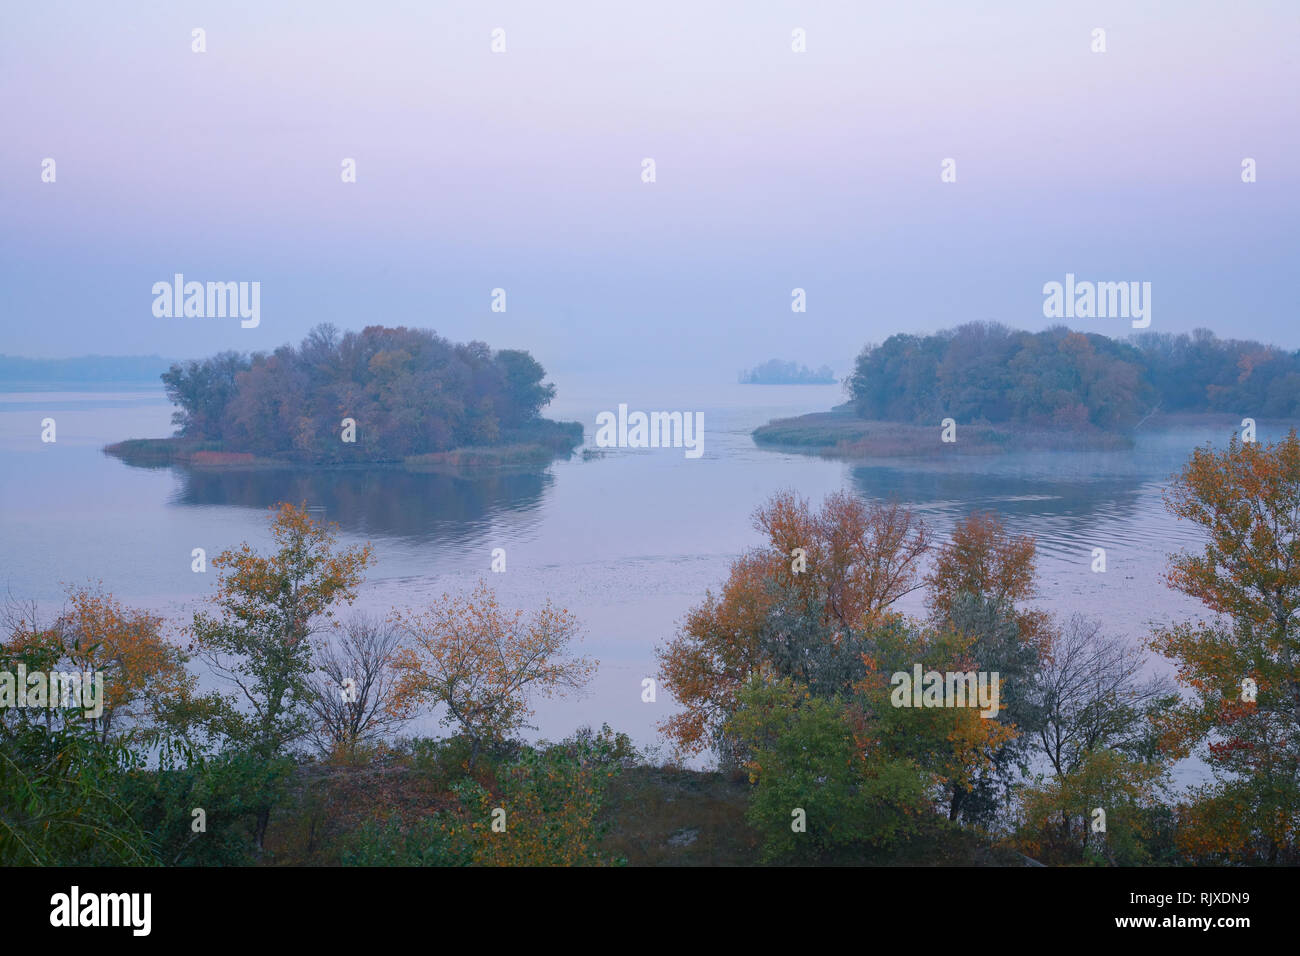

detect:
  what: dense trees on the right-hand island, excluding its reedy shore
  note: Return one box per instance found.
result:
[848,323,1300,429]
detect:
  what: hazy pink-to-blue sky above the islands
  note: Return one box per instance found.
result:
[0,0,1300,388]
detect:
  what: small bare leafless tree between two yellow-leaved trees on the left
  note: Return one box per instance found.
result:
[308,615,407,756]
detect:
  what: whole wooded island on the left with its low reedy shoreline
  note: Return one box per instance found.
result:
[104,324,582,470]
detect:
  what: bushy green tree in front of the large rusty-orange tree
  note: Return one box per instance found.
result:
[725,615,1017,862]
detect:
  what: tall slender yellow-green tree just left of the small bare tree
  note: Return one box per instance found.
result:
[190,502,372,849]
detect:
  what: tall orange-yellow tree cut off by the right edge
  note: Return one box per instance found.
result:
[1151,429,1300,864]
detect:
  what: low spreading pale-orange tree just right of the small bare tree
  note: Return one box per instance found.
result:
[393,581,597,766]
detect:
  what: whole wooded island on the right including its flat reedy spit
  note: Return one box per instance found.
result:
[754,323,1300,458]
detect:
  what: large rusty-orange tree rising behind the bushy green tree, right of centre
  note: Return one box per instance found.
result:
[657,492,930,763]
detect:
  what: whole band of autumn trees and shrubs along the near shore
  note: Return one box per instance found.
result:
[0,432,1300,865]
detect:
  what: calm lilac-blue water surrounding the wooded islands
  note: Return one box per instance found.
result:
[0,385,1271,778]
